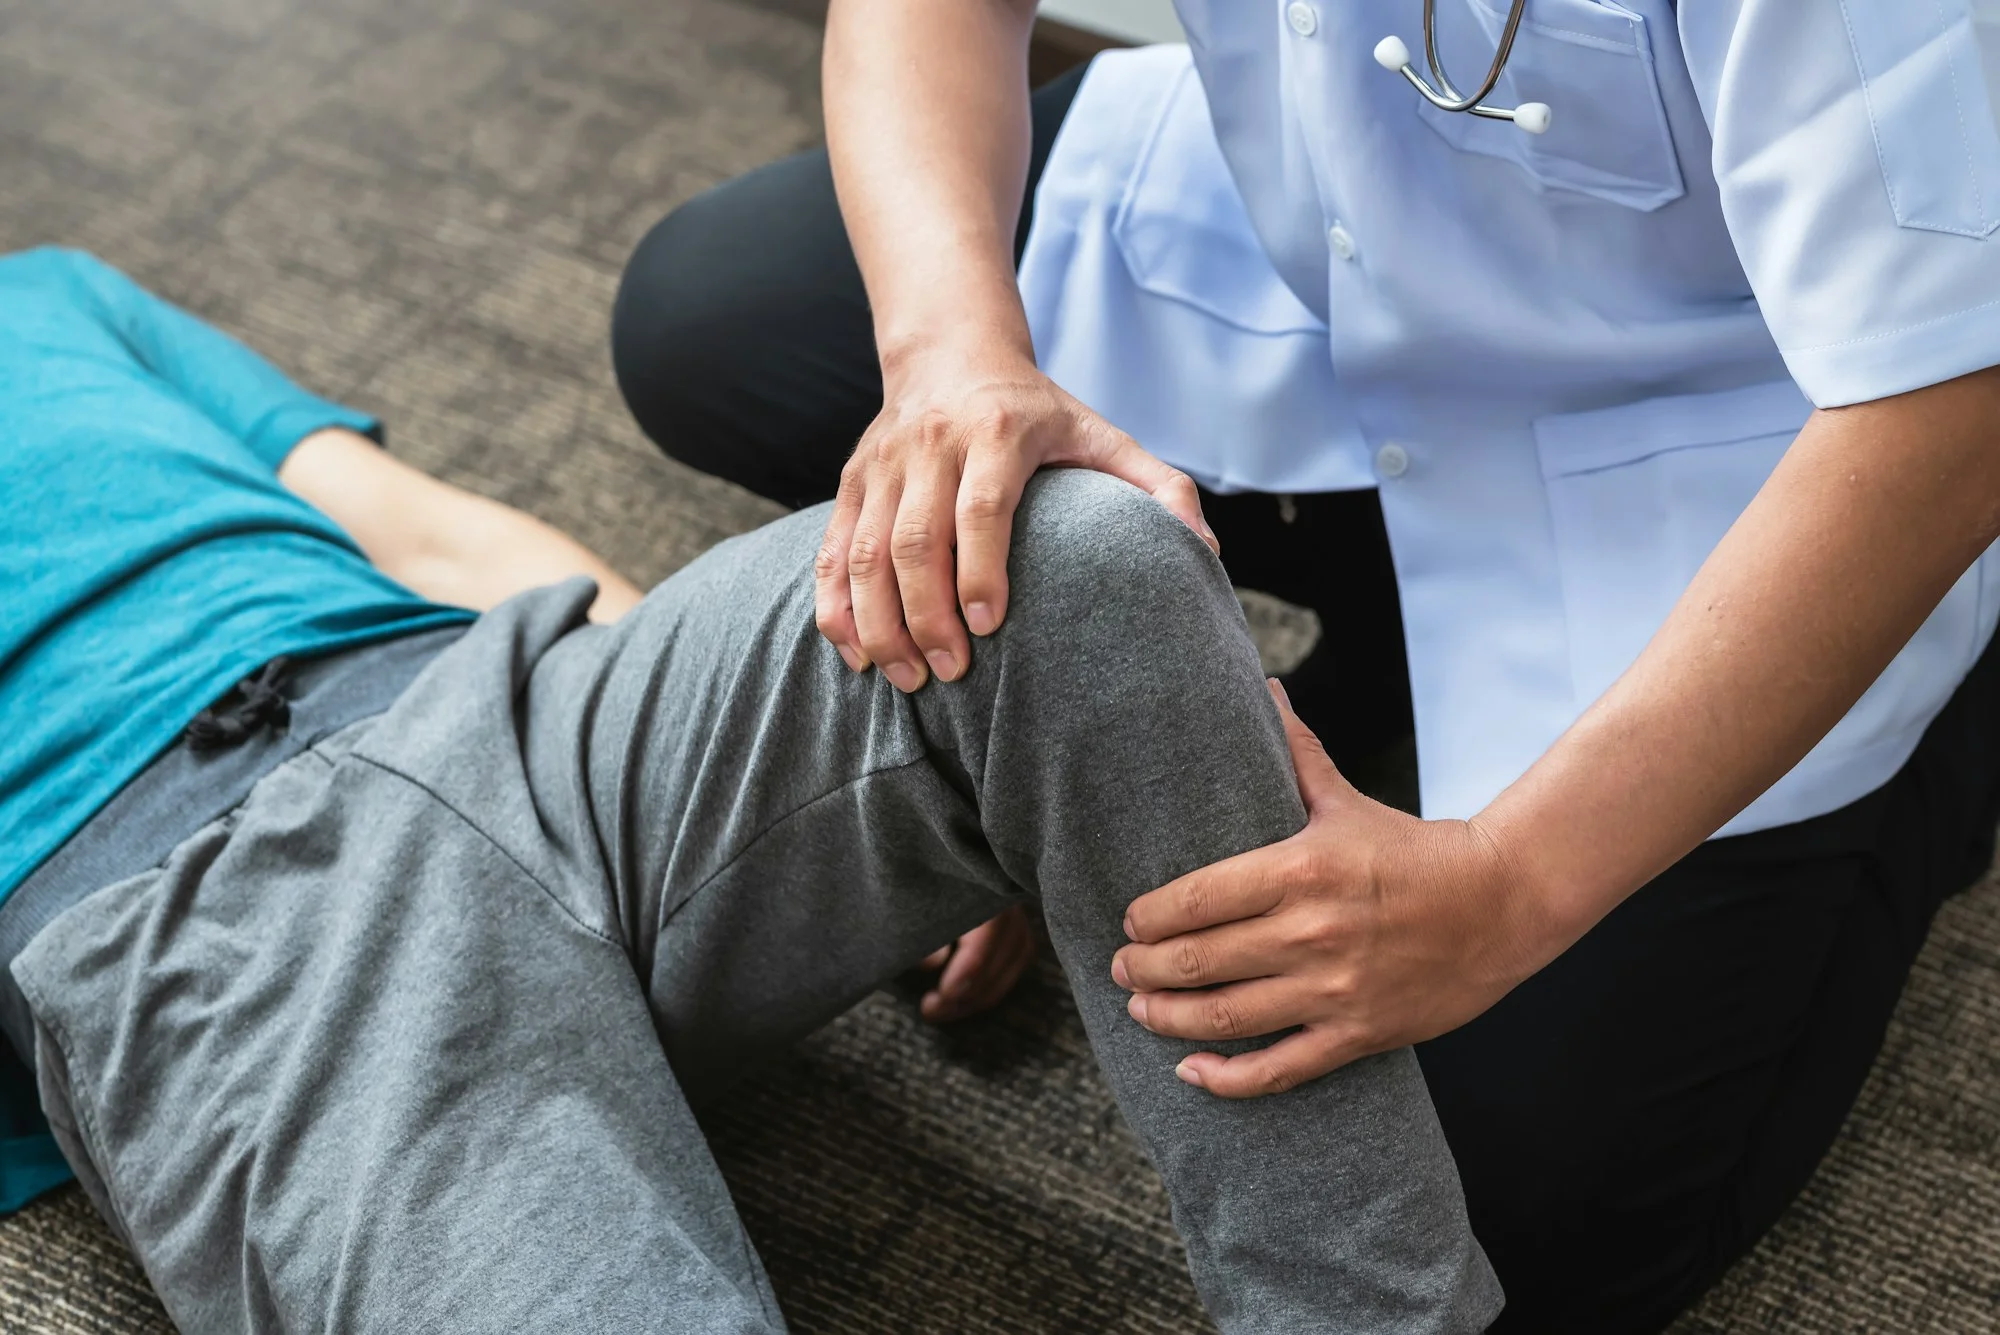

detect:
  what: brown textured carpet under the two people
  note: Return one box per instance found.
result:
[0,0,2000,1335]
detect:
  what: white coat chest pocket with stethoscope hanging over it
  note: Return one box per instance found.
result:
[1416,0,1686,212]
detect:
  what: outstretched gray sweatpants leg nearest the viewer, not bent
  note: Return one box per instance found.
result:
[14,715,784,1335]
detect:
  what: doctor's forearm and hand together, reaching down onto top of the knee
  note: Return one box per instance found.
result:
[812,0,1214,691]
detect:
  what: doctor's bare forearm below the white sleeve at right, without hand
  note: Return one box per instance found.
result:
[1474,368,2000,943]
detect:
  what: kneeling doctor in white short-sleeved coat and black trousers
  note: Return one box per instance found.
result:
[614,0,2000,1335]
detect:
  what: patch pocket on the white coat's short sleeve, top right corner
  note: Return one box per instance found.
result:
[1840,0,2000,238]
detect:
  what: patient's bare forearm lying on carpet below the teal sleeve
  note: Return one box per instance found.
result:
[278,428,640,622]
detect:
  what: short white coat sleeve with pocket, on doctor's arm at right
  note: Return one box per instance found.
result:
[1678,0,2000,408]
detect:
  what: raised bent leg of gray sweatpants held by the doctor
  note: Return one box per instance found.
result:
[410,472,1498,1335]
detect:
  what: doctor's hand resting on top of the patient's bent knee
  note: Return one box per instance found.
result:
[814,352,1216,691]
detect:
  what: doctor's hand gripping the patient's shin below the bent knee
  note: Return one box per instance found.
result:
[1112,681,1574,1099]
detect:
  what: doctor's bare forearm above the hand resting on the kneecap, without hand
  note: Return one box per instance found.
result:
[824,0,1034,380]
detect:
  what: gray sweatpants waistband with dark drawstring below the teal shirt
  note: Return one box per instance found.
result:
[0,626,466,979]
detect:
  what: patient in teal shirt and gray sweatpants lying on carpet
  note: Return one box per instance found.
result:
[0,250,1500,1335]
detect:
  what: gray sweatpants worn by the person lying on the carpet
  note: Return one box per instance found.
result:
[14,472,1500,1335]
